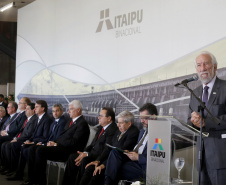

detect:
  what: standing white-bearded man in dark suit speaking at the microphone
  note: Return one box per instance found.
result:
[188,52,226,185]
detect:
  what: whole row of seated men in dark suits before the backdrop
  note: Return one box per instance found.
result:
[0,97,157,185]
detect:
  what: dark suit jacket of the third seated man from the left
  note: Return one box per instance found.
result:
[8,111,27,137]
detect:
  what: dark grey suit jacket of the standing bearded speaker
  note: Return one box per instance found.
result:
[188,78,226,169]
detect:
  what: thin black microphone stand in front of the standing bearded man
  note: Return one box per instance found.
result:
[182,83,220,185]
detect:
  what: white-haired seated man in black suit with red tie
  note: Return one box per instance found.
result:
[19,100,90,185]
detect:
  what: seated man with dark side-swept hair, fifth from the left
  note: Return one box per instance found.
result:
[7,100,52,182]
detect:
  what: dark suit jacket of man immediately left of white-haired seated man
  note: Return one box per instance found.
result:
[48,115,67,141]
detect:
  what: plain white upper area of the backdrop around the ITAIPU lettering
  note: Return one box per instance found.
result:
[16,0,226,93]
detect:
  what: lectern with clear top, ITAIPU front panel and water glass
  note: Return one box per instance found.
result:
[146,116,203,185]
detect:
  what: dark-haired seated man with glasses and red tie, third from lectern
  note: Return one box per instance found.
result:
[63,107,117,185]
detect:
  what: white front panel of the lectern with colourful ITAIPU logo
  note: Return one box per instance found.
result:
[146,120,171,184]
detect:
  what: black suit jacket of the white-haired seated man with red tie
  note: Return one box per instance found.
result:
[55,116,90,153]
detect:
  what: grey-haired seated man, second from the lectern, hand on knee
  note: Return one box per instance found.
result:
[76,111,139,185]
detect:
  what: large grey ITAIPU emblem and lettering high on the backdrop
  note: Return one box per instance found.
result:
[96,9,143,33]
